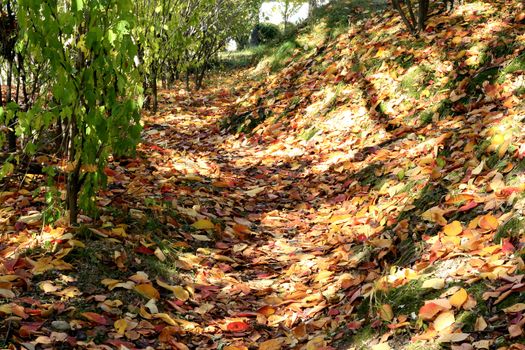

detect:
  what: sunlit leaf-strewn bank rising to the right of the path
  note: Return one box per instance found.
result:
[219,1,525,348]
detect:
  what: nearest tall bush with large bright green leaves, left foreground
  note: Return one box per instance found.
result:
[17,0,141,222]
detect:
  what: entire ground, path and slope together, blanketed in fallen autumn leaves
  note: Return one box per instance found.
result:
[4,1,525,350]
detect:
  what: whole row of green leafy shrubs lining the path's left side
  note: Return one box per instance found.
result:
[0,0,262,224]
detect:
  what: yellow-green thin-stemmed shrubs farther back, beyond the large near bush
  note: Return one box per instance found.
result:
[133,0,262,111]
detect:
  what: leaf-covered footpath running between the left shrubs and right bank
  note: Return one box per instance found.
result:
[123,81,351,349]
